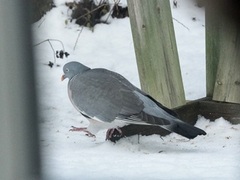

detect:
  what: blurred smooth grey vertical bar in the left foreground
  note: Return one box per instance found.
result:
[0,0,40,180]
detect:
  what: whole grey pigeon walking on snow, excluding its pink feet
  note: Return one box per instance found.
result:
[62,62,206,139]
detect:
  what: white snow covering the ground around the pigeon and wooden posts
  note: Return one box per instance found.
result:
[32,0,240,179]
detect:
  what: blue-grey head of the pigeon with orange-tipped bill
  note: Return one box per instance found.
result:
[61,61,90,81]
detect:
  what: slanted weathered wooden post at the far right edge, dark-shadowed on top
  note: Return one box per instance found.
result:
[213,21,240,103]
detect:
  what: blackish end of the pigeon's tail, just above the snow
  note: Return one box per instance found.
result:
[163,121,206,139]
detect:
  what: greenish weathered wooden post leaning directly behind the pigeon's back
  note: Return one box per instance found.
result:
[128,0,185,108]
